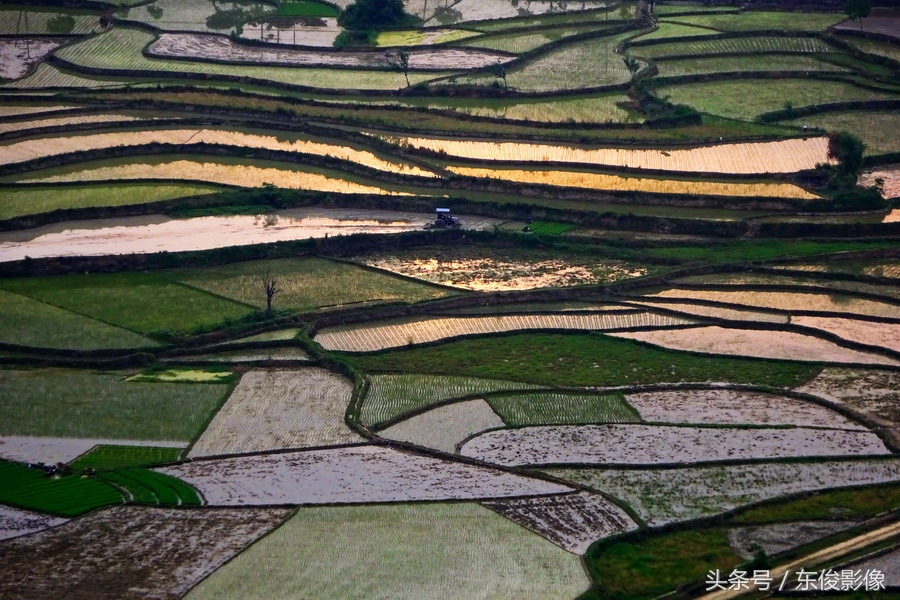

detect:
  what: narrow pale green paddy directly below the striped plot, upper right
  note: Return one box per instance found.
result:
[657,54,849,77]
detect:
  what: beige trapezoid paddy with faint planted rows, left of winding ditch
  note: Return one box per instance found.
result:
[189,368,362,458]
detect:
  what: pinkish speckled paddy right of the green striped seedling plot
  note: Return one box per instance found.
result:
[626,389,866,430]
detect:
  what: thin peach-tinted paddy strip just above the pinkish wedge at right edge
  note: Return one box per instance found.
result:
[648,289,897,317]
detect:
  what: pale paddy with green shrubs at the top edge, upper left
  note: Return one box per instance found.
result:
[116,0,273,33]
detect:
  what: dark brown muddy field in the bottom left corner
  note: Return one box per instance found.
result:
[0,507,288,600]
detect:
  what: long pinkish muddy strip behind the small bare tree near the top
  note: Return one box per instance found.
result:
[147,33,514,71]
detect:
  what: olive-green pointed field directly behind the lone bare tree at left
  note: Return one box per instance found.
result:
[165,258,454,310]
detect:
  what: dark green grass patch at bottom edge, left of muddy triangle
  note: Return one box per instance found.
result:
[585,529,742,600]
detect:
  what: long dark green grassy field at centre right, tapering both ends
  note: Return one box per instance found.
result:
[353,334,820,387]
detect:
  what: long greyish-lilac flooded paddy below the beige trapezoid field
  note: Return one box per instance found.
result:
[160,446,572,506]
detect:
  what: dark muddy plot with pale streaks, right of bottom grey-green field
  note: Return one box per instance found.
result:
[482,492,637,554]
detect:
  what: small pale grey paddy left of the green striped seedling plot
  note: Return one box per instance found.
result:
[378,400,503,453]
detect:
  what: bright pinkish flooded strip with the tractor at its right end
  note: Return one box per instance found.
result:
[0,208,500,262]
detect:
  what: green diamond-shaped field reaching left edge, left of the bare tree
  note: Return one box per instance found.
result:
[0,272,253,333]
